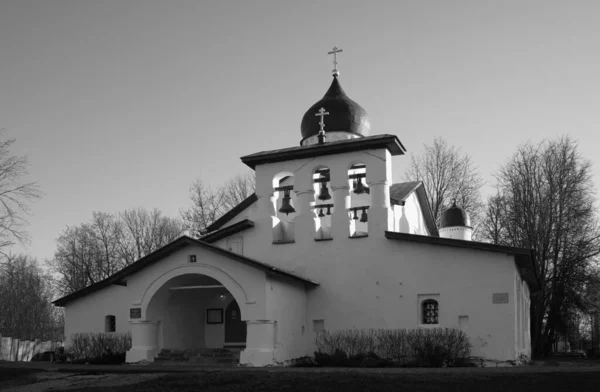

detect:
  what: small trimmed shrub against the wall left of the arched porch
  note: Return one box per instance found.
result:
[67,332,131,364]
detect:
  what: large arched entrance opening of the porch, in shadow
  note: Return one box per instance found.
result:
[146,273,246,351]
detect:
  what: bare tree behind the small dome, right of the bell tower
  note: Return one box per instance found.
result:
[404,137,484,231]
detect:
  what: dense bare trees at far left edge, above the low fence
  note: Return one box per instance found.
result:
[0,255,62,340]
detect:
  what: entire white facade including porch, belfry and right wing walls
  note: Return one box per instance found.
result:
[58,137,531,366]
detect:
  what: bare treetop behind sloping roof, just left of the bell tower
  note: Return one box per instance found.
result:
[180,172,255,237]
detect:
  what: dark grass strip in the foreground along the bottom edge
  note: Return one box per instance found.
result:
[55,369,600,392]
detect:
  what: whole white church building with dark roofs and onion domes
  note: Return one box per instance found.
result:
[54,62,539,366]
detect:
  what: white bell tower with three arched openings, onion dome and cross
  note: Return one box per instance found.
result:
[241,47,405,253]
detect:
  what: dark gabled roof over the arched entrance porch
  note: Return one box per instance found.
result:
[52,236,319,306]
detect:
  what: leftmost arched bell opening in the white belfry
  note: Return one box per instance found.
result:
[272,172,296,244]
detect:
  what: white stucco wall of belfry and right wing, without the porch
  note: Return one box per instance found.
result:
[207,145,530,360]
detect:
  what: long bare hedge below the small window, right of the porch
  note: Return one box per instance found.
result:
[315,328,471,367]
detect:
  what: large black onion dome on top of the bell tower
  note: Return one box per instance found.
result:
[300,77,371,140]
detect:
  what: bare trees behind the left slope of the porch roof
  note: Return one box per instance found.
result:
[47,208,183,295]
